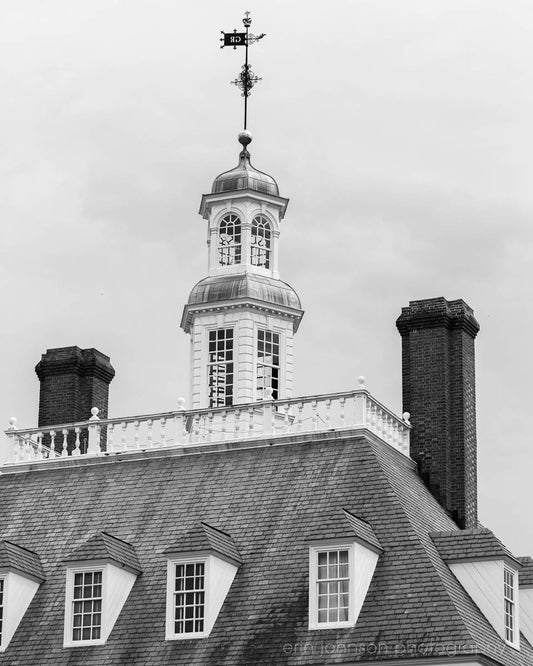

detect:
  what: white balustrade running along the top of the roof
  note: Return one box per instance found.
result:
[5,384,411,462]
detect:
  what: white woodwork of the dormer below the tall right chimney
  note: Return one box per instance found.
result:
[449,560,520,647]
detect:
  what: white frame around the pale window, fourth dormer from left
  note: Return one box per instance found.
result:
[309,540,355,629]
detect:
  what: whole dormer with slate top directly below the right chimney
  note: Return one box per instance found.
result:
[430,528,521,650]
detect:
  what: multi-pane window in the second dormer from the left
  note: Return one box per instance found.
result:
[71,570,103,641]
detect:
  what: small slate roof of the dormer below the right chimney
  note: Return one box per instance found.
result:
[430,527,519,564]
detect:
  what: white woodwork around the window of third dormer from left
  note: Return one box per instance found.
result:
[165,551,239,640]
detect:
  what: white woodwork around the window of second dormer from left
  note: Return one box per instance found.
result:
[63,560,138,647]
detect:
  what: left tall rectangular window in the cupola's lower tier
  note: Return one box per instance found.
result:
[208,328,233,407]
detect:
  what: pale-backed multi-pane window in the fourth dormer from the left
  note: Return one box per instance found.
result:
[316,548,350,624]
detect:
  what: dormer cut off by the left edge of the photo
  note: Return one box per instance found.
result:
[0,541,44,652]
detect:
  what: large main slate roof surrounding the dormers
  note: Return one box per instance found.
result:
[0,431,533,666]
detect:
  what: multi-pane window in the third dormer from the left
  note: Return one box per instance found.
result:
[173,562,205,634]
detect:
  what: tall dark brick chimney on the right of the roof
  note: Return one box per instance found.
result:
[396,297,479,528]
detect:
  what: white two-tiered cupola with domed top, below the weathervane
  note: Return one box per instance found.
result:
[181,131,303,409]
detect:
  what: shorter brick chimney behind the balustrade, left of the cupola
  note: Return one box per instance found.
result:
[35,347,115,427]
